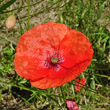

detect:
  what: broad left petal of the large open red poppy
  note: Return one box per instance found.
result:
[14,22,70,79]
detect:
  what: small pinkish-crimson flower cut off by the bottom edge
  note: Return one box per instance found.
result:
[66,99,79,110]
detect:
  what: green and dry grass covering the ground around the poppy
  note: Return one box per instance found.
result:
[0,0,110,110]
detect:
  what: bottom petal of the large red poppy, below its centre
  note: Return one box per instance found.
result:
[30,59,88,89]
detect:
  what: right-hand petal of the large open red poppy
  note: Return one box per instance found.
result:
[60,30,93,69]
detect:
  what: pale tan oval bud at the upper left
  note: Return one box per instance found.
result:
[6,15,16,29]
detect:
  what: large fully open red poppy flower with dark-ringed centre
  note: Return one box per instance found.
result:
[14,22,93,89]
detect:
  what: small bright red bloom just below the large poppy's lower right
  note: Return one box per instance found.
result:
[75,78,86,92]
